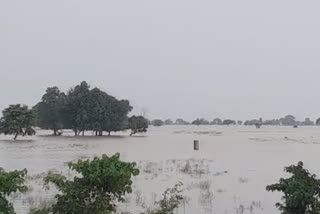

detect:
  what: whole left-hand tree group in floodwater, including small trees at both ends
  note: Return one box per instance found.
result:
[0,82,148,139]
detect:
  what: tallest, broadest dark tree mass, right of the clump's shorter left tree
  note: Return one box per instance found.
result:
[65,82,132,136]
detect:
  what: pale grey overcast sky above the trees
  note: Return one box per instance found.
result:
[0,0,320,120]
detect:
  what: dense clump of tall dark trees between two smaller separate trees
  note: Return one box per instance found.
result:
[34,82,132,136]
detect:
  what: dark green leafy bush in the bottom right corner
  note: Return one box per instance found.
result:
[267,162,320,214]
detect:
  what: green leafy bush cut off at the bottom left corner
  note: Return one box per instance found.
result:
[0,168,27,214]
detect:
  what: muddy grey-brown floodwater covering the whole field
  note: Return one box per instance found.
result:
[0,126,320,214]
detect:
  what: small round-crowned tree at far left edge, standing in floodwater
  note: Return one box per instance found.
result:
[0,104,35,140]
